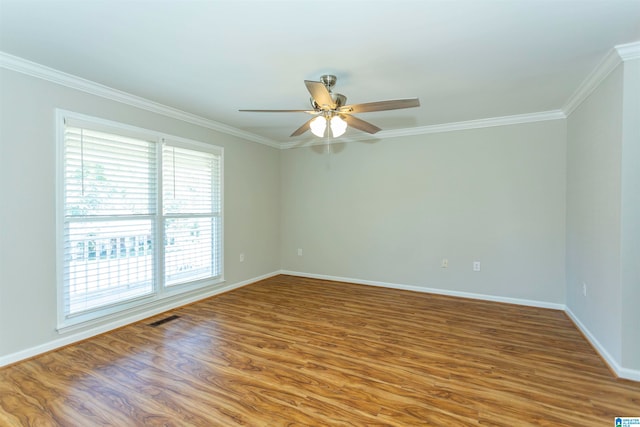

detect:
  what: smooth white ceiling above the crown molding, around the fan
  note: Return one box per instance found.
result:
[0,0,640,143]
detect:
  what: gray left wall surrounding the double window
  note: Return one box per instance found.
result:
[0,69,280,358]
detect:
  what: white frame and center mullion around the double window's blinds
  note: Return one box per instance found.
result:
[55,109,224,333]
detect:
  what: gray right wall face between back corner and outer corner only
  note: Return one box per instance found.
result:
[567,66,622,360]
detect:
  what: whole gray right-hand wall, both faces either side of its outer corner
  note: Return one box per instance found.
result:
[567,60,640,371]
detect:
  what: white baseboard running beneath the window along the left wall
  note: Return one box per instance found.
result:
[0,271,280,368]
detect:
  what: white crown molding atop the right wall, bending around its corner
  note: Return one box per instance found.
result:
[562,42,640,117]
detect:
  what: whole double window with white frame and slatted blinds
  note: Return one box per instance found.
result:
[58,111,222,329]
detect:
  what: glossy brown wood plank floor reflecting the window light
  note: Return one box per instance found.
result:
[0,276,640,427]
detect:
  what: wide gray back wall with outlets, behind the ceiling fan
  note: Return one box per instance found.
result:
[281,120,566,304]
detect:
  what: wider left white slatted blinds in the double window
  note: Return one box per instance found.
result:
[64,126,157,315]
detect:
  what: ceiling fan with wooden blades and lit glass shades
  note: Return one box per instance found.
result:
[239,75,420,138]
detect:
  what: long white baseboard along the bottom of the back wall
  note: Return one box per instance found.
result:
[280,270,566,310]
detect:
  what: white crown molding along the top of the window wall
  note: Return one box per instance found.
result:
[0,51,281,148]
